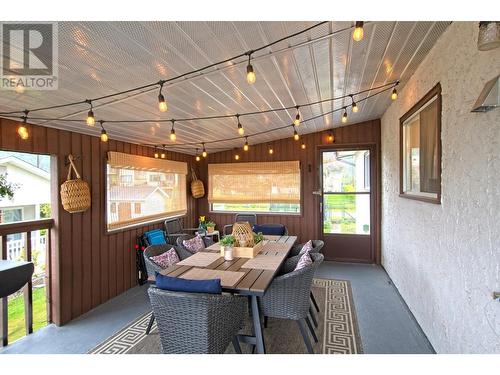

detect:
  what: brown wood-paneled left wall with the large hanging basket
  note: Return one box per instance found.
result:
[0,118,197,325]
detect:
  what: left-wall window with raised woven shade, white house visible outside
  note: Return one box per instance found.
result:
[106,152,187,230]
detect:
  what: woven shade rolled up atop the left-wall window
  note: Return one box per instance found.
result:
[108,151,187,175]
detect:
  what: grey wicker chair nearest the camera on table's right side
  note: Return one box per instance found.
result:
[261,253,323,354]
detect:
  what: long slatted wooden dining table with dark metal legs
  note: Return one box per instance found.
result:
[149,236,297,354]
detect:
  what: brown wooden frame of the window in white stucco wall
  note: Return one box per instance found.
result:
[399,83,442,204]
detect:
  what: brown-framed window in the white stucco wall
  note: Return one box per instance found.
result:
[400,84,441,203]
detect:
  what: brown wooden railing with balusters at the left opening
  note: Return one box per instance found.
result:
[0,219,54,346]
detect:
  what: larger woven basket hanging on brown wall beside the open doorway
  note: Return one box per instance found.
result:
[61,154,90,213]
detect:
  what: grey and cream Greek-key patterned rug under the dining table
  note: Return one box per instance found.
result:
[89,279,363,354]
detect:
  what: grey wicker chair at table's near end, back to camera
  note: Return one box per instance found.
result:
[148,286,247,354]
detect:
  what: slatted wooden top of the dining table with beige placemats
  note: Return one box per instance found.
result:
[150,236,297,295]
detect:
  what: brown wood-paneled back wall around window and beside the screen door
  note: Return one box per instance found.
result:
[198,120,380,254]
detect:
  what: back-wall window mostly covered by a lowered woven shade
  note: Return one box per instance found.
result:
[208,161,300,213]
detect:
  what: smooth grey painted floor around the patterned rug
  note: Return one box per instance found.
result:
[0,262,434,354]
